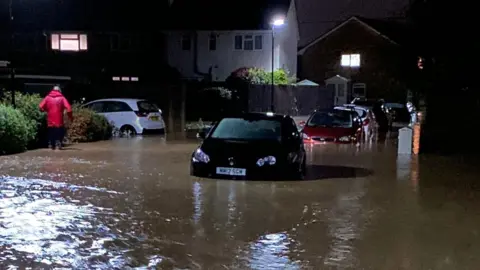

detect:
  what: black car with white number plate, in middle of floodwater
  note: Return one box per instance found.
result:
[190,113,306,180]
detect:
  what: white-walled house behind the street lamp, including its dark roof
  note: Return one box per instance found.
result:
[167,0,299,81]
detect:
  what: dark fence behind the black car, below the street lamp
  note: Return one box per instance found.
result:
[248,85,334,116]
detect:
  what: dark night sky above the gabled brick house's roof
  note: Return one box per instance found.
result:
[296,0,409,46]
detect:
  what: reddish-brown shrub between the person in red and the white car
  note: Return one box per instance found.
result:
[67,105,113,142]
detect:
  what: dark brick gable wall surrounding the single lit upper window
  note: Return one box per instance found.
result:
[300,20,405,98]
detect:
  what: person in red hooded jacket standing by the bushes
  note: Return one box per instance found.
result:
[40,86,73,150]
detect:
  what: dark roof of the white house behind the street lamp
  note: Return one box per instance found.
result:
[168,0,293,30]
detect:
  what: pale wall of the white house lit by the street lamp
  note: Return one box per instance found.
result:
[167,1,298,81]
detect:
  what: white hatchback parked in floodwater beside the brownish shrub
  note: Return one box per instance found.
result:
[83,98,165,135]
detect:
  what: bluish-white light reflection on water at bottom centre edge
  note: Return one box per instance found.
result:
[249,232,300,269]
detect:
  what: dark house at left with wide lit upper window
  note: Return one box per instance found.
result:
[0,0,172,99]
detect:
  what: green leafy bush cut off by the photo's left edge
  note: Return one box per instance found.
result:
[0,104,35,154]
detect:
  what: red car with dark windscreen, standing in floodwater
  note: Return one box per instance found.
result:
[300,109,363,144]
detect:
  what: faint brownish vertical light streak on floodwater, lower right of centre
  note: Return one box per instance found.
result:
[324,190,365,267]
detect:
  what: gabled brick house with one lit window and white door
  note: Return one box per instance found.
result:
[299,17,416,104]
